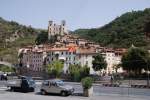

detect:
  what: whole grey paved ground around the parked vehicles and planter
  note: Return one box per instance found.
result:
[0,81,150,100]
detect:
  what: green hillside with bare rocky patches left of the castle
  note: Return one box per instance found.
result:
[0,18,40,63]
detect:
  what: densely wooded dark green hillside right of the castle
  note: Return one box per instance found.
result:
[74,8,150,49]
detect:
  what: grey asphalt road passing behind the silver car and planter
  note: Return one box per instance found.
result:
[0,81,150,97]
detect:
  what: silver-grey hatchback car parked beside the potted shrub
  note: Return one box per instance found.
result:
[41,79,74,96]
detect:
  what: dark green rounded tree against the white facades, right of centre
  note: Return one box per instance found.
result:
[92,54,107,71]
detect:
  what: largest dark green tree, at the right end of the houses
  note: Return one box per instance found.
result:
[121,47,149,75]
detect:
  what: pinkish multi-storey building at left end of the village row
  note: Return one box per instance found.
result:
[18,48,44,76]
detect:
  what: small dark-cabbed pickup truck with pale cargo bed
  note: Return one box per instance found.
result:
[7,76,35,92]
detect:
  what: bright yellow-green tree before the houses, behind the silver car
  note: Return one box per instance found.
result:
[47,60,63,78]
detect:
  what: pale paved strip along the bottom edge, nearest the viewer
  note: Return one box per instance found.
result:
[0,91,149,100]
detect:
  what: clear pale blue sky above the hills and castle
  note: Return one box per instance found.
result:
[0,0,150,30]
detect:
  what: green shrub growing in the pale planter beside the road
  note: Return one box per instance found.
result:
[82,77,93,89]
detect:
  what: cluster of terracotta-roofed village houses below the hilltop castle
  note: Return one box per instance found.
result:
[20,34,126,74]
